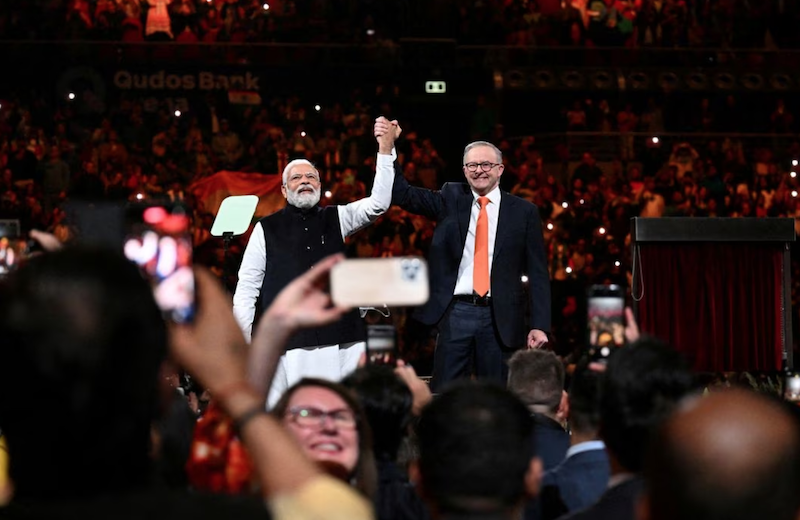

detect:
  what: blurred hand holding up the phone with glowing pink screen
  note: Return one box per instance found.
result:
[169,269,248,394]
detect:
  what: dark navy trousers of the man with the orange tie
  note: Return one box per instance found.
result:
[431,301,513,392]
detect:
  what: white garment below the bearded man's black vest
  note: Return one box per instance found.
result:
[267,341,366,409]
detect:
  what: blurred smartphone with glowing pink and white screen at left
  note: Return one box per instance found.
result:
[124,204,196,323]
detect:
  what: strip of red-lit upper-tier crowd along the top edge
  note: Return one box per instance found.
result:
[0,0,800,48]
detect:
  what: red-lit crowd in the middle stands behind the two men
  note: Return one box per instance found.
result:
[0,81,800,366]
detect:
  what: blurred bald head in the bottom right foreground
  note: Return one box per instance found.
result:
[643,390,800,520]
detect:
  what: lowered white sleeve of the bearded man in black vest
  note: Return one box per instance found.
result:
[233,222,267,341]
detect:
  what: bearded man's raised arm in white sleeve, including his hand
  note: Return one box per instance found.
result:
[338,117,402,238]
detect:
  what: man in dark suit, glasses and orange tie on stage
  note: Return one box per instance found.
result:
[375,118,550,389]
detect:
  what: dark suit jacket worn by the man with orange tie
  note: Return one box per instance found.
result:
[392,169,550,349]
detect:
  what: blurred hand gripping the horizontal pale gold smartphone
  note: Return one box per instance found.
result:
[256,254,349,335]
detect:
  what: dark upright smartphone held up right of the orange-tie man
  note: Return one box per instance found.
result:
[586,284,625,362]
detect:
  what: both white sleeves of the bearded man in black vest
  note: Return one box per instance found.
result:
[233,150,396,346]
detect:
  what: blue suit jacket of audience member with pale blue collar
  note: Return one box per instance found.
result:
[540,449,610,520]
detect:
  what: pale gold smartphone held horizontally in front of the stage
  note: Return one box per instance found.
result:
[331,257,430,307]
